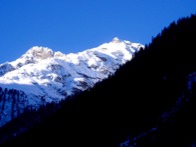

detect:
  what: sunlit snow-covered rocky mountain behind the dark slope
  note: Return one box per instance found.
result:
[0,37,143,126]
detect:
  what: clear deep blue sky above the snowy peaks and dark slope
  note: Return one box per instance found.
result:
[0,0,196,63]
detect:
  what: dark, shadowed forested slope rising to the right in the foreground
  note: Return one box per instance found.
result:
[0,15,196,147]
